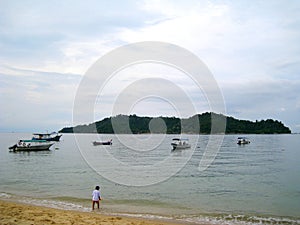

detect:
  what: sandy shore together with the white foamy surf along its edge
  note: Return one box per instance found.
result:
[0,198,300,225]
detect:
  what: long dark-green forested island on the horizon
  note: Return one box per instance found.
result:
[59,112,291,134]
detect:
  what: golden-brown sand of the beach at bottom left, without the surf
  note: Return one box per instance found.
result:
[0,200,192,225]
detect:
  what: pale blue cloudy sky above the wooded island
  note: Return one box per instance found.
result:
[0,0,300,132]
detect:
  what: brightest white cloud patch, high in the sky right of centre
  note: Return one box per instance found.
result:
[120,2,231,50]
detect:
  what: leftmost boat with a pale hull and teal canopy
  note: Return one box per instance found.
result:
[9,140,54,151]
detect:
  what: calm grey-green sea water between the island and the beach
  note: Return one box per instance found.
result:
[0,133,300,224]
